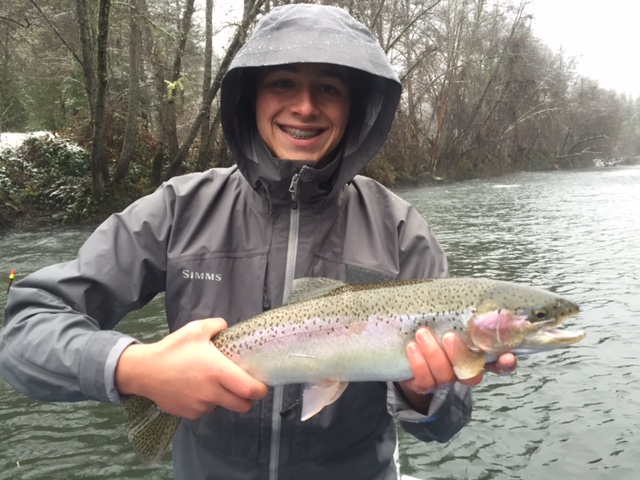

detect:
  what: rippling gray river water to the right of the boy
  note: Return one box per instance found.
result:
[398,167,640,480]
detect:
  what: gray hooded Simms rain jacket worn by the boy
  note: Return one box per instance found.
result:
[0,5,471,480]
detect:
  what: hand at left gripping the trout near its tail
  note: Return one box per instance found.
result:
[116,318,268,419]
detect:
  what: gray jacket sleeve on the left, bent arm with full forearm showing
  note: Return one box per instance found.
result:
[0,187,173,402]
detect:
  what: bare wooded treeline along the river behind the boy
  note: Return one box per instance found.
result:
[0,0,640,224]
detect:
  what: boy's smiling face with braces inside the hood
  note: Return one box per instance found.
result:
[256,63,351,162]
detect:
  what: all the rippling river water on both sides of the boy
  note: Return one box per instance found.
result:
[0,167,640,480]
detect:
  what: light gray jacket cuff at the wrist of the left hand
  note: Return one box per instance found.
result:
[78,330,137,403]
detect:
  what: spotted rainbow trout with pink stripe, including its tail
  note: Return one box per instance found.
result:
[124,278,585,463]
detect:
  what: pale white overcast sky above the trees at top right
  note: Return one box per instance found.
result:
[528,0,640,98]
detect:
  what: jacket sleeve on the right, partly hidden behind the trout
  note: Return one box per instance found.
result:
[387,202,472,442]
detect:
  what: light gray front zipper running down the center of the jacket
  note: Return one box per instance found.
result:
[269,171,305,480]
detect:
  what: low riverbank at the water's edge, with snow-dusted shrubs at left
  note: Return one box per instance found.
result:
[0,132,639,231]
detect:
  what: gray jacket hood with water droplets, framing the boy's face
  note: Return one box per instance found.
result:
[220,4,402,196]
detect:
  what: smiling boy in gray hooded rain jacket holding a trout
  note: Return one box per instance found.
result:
[0,5,515,480]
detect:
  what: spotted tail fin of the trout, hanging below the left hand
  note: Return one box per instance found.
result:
[122,395,180,465]
